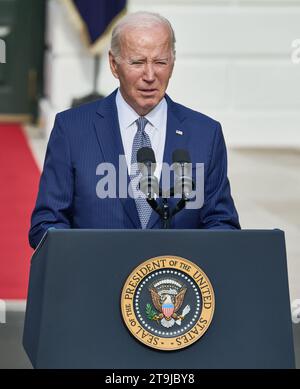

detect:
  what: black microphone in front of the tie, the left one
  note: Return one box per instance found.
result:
[137,147,159,199]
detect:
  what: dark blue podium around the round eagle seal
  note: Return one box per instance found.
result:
[23,229,295,369]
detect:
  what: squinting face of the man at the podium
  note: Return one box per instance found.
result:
[109,25,174,116]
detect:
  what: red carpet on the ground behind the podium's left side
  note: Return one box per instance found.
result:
[0,124,40,299]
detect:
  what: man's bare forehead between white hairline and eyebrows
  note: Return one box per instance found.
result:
[120,24,171,55]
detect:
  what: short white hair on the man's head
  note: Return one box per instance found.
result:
[110,11,176,59]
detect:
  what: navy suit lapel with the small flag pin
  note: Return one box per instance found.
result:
[147,95,188,228]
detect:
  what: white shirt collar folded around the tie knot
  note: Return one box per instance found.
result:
[116,89,167,130]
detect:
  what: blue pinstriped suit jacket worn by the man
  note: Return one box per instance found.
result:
[29,91,240,248]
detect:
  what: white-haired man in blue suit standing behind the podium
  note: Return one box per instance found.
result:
[29,12,240,248]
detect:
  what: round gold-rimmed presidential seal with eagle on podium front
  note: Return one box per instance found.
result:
[121,256,215,351]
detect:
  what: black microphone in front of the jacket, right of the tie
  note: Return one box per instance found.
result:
[172,149,193,199]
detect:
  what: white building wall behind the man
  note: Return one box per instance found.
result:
[41,0,300,147]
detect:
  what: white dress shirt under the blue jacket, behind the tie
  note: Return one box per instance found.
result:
[116,89,168,180]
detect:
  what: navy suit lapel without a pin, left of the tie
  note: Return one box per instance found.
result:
[94,91,141,228]
